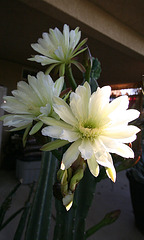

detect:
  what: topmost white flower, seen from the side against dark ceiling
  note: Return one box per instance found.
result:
[29,24,86,75]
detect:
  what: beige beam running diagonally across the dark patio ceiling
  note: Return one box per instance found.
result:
[21,0,144,57]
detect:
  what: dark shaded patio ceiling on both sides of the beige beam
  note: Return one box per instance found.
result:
[0,0,144,86]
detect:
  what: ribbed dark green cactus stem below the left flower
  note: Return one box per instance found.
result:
[25,152,57,240]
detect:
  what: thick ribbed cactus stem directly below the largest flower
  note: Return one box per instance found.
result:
[53,168,97,240]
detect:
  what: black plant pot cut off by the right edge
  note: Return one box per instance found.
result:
[127,171,144,234]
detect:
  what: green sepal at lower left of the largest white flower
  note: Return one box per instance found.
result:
[41,139,69,151]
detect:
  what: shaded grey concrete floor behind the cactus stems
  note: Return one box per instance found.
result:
[0,170,144,240]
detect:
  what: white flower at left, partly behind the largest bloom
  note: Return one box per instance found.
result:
[1,72,64,133]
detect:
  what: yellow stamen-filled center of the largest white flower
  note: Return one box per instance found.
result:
[79,123,101,140]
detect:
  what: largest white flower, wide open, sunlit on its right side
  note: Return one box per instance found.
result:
[42,82,140,181]
